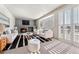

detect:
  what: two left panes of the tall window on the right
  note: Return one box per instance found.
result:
[58,9,71,40]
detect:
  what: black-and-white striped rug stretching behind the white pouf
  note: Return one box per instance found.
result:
[3,35,50,51]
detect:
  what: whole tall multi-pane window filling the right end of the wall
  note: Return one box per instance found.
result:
[58,6,79,44]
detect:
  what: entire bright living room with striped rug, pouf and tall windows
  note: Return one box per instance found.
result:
[0,4,79,54]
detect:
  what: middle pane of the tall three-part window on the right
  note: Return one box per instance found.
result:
[63,9,71,40]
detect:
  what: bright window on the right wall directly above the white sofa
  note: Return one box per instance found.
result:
[40,16,54,30]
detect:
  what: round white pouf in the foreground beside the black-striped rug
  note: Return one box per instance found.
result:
[28,39,40,53]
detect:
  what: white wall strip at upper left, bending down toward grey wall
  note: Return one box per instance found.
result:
[0,4,15,28]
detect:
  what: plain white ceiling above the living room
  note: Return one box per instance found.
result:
[5,4,62,19]
